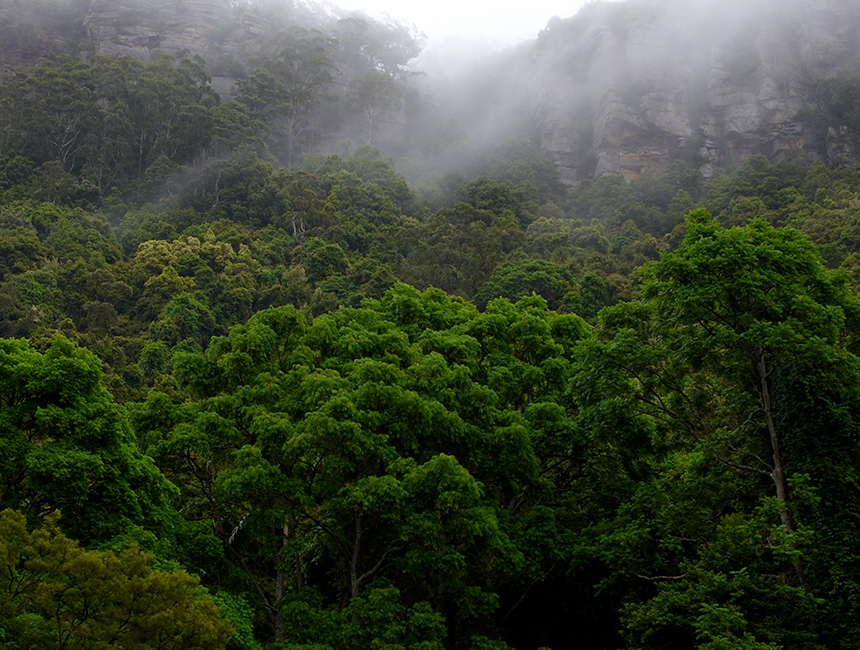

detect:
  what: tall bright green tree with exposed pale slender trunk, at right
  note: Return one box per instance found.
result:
[576,211,860,648]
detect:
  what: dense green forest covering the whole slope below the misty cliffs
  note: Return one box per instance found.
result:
[0,2,860,650]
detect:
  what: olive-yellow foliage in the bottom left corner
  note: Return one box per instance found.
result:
[0,510,232,650]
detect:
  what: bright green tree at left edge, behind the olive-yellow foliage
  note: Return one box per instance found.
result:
[0,335,171,542]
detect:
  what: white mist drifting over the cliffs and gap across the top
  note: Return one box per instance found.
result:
[0,0,860,195]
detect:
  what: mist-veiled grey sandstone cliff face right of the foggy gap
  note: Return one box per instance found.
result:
[529,0,860,184]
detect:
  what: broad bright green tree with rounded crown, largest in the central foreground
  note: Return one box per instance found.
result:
[135,285,586,648]
